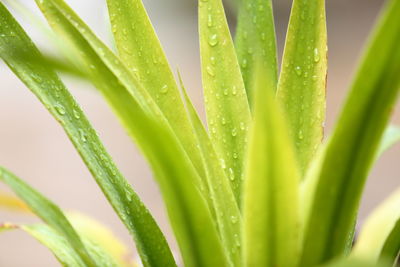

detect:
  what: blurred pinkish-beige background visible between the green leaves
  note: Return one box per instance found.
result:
[0,0,400,267]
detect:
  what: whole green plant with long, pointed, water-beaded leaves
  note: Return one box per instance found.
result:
[0,0,400,267]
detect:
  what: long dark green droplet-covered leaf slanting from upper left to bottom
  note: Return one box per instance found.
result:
[0,5,174,266]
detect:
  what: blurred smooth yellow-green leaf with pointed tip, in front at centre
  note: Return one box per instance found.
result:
[243,69,300,266]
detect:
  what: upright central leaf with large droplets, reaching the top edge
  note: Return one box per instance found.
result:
[199,0,251,203]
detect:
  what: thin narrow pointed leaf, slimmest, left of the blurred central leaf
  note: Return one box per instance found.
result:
[178,74,242,266]
